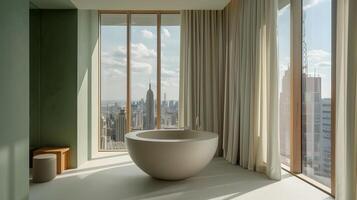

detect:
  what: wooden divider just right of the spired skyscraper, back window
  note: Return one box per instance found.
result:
[156,14,161,129]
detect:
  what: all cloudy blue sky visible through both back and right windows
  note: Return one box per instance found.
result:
[101,0,331,104]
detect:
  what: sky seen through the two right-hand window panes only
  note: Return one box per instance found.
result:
[278,0,331,98]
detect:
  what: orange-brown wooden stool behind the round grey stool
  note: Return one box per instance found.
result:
[33,147,70,174]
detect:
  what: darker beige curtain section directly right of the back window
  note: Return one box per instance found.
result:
[179,10,224,155]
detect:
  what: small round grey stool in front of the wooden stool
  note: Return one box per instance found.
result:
[32,154,57,183]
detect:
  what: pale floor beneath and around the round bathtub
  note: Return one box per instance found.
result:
[30,159,332,200]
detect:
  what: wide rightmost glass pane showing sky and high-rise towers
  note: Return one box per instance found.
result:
[302,0,331,186]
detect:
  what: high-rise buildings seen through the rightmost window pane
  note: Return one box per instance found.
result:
[302,74,331,185]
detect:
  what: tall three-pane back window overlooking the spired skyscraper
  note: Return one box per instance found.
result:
[99,12,180,151]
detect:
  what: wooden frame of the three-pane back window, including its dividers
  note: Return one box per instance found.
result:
[98,10,180,152]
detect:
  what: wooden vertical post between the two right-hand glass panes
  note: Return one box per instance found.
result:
[290,0,302,173]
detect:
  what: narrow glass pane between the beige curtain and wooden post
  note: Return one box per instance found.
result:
[278,0,291,167]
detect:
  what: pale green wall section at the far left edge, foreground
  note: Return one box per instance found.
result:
[0,0,29,200]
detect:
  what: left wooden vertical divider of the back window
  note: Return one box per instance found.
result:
[126,13,131,132]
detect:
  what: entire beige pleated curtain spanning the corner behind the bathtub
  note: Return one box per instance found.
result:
[179,0,281,179]
